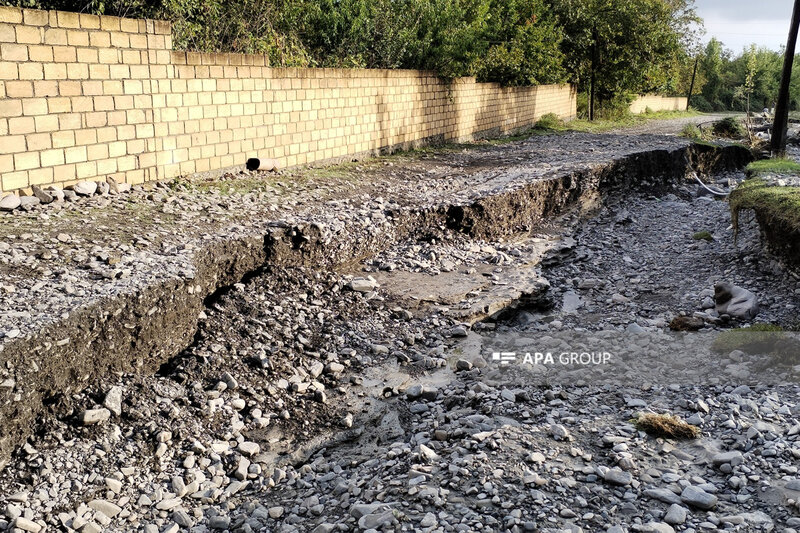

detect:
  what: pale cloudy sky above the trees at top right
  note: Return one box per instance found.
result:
[695,0,794,53]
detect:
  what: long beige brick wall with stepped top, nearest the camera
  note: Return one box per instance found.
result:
[0,7,575,191]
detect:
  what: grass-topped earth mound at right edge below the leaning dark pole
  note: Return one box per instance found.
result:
[728,177,800,233]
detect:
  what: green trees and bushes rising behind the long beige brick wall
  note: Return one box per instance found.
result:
[0,0,699,119]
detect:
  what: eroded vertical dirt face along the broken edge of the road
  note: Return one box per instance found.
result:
[0,141,750,466]
